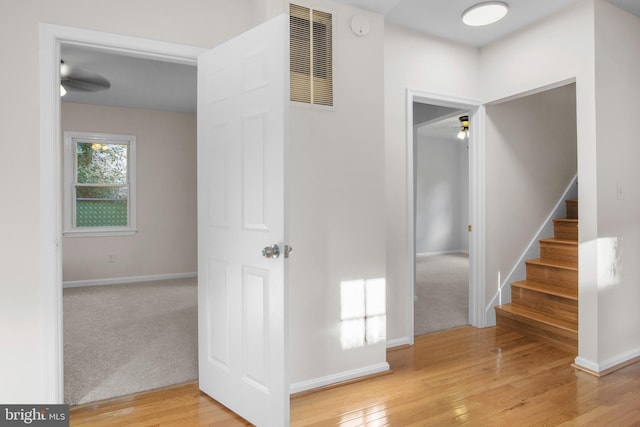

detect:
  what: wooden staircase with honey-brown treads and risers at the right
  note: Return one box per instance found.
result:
[496,200,578,354]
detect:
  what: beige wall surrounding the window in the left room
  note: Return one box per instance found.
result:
[61,102,197,282]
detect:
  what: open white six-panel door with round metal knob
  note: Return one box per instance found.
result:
[198,15,289,427]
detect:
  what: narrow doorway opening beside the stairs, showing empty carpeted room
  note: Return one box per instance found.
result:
[414,108,470,335]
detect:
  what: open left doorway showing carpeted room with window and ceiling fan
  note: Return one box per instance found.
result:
[60,43,198,405]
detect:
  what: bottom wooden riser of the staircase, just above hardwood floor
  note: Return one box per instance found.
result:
[496,307,578,354]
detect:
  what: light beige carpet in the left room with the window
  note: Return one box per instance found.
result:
[63,278,198,405]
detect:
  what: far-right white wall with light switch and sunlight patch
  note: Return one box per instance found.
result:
[592,2,640,369]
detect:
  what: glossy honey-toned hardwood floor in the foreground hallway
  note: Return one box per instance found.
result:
[71,327,640,427]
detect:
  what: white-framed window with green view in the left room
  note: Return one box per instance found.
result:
[64,132,136,236]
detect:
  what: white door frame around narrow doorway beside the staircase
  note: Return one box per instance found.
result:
[404,89,487,344]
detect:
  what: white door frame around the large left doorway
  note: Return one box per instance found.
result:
[38,23,206,403]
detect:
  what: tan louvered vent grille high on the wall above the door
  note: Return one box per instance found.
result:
[289,4,333,106]
